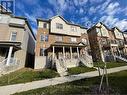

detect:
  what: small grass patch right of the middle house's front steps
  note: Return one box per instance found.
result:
[68,66,96,75]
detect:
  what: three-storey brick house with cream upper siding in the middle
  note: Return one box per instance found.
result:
[34,16,92,69]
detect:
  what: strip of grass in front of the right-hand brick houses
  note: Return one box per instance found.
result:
[94,62,127,68]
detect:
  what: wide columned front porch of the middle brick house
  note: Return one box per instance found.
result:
[45,43,92,68]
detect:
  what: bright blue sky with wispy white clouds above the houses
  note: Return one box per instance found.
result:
[4,0,127,34]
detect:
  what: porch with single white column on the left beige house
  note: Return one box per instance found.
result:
[0,41,21,66]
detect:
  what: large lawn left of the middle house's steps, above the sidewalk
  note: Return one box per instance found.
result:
[0,68,59,86]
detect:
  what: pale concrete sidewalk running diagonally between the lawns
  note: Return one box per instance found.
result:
[0,66,127,95]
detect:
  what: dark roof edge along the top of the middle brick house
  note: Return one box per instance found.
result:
[37,15,87,29]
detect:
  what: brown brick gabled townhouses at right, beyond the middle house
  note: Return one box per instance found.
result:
[88,22,126,62]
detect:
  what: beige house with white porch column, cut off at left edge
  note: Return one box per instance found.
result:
[0,5,35,73]
